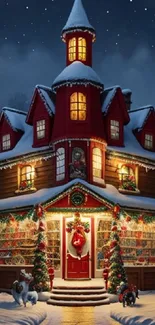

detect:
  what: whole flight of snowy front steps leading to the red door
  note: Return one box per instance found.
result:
[47,284,110,307]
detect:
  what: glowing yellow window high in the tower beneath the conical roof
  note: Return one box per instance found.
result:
[68,37,87,62]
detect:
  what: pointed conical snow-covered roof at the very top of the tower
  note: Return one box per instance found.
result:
[62,0,95,38]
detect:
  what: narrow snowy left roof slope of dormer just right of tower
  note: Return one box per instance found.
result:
[102,86,120,114]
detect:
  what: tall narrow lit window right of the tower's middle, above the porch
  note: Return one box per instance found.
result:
[93,148,102,179]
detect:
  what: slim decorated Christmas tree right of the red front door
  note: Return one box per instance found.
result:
[108,206,127,294]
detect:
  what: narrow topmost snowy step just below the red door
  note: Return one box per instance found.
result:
[52,288,106,295]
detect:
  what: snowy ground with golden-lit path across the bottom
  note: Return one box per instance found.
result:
[0,291,155,325]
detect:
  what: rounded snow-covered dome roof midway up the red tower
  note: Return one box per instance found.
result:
[52,61,103,89]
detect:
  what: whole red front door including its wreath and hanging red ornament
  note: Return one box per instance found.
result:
[65,217,91,279]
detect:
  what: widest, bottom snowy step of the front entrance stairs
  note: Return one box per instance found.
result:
[47,298,110,307]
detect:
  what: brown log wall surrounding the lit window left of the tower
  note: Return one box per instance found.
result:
[0,157,55,199]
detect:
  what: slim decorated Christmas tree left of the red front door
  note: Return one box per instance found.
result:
[32,206,50,292]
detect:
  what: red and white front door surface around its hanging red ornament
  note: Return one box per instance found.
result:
[64,218,92,279]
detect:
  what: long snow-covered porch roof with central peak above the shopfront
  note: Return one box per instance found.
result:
[0,179,155,211]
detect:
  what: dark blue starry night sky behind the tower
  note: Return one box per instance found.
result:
[0,0,155,110]
